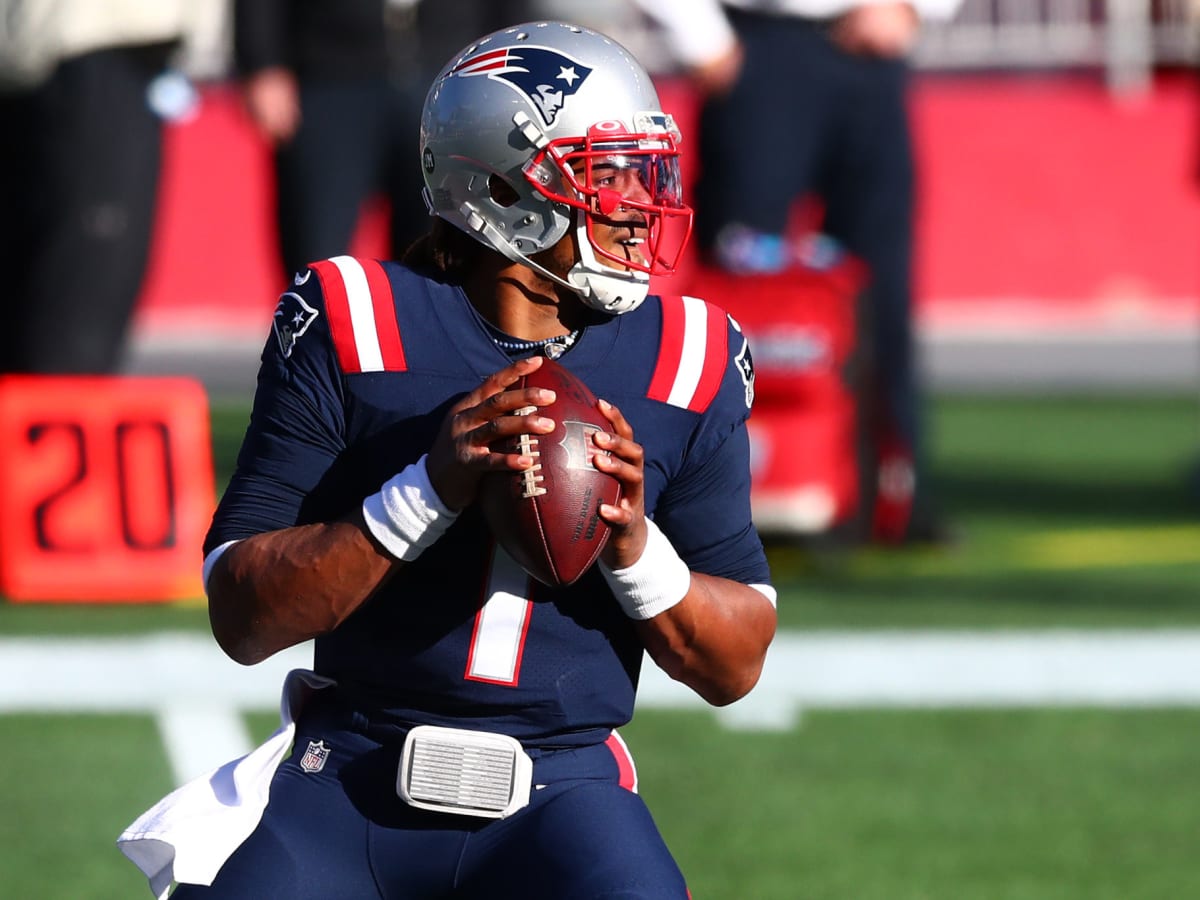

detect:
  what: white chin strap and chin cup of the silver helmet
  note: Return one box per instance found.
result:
[460,204,650,316]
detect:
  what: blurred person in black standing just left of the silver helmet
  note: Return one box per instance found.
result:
[234,0,527,278]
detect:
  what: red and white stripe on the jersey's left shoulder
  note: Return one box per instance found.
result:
[308,256,408,374]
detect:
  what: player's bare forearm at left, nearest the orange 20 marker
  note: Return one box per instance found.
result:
[208,521,393,665]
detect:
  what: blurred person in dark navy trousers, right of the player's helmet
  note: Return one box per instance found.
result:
[635,0,960,541]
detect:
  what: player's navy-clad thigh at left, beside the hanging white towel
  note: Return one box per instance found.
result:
[172,763,379,900]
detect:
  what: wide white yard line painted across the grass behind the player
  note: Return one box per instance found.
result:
[0,629,1200,780]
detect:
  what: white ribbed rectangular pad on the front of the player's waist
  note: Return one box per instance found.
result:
[396,725,533,818]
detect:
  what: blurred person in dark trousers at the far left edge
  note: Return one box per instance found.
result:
[0,0,194,374]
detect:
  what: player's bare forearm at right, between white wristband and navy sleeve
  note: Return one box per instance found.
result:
[637,572,775,706]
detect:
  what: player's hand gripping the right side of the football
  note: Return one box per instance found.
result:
[592,400,646,569]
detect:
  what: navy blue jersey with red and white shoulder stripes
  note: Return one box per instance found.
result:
[205,257,769,745]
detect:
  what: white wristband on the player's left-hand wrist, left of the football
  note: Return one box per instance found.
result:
[362,456,458,563]
